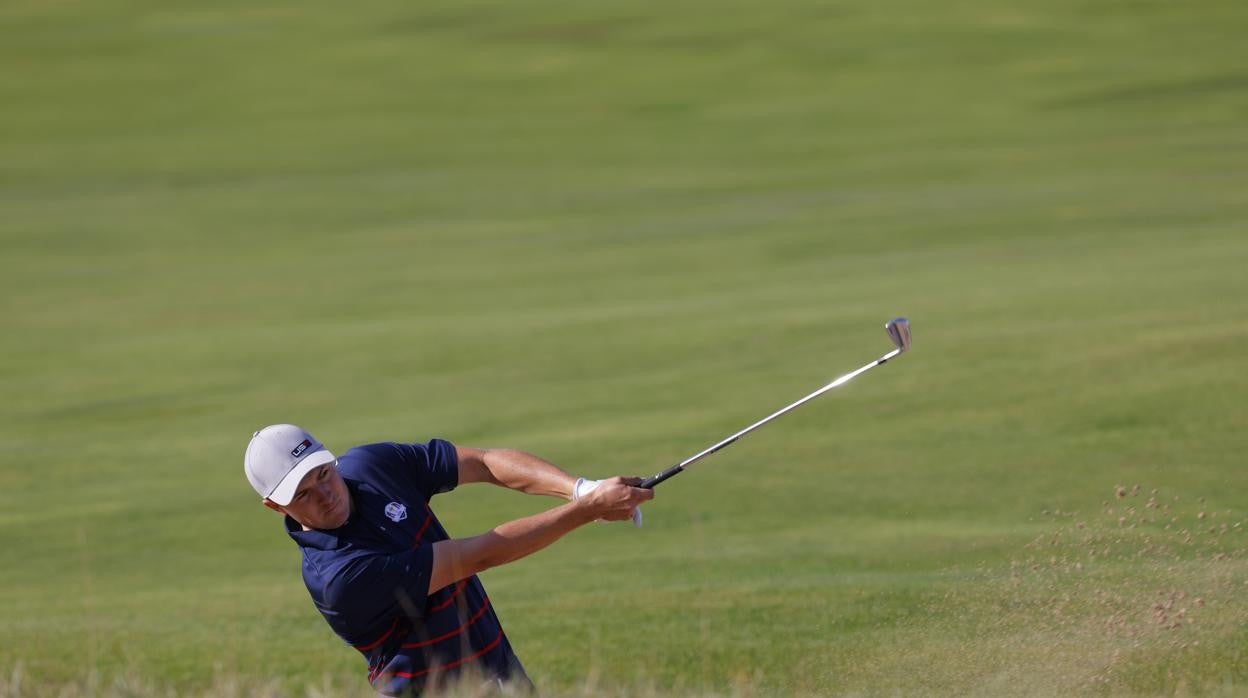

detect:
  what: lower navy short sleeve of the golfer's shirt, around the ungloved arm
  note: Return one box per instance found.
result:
[324,546,433,626]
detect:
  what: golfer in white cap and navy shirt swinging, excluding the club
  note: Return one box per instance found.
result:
[243,425,654,696]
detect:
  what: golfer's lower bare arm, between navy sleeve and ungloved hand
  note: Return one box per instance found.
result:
[429,502,594,594]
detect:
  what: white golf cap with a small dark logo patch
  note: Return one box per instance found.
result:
[242,425,336,507]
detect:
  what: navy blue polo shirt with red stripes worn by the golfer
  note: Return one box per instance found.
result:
[286,440,528,696]
